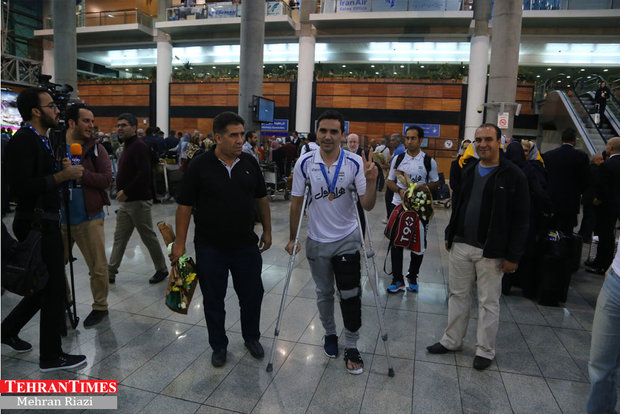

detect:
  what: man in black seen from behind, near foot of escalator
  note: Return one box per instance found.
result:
[543,128,590,235]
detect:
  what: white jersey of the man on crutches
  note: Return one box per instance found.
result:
[291,149,366,243]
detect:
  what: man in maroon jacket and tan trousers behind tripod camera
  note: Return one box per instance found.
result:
[62,104,113,327]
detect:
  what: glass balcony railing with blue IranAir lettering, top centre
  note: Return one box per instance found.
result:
[321,0,464,13]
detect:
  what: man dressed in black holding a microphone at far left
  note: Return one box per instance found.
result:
[2,88,86,372]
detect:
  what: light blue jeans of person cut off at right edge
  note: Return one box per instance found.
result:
[587,269,620,414]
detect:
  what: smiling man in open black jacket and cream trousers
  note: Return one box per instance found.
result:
[426,124,530,370]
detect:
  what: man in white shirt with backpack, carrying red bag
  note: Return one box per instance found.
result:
[387,125,439,293]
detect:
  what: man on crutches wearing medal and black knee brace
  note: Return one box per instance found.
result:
[286,110,378,374]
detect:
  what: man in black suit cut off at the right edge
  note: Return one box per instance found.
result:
[586,137,620,275]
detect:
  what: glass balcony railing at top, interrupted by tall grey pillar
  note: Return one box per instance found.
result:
[166,1,291,21]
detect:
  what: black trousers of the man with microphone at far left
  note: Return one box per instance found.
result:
[2,220,66,361]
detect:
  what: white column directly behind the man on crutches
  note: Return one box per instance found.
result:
[295,29,315,133]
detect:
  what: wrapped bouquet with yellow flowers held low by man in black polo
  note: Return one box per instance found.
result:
[157,221,198,315]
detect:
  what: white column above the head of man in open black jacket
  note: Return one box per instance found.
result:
[463,34,489,141]
